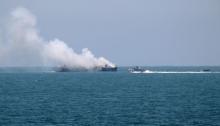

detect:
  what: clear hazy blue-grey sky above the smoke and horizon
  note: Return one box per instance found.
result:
[0,0,220,66]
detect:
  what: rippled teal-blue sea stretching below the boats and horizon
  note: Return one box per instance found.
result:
[0,67,220,126]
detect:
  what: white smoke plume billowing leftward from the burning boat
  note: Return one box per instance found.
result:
[0,7,115,69]
